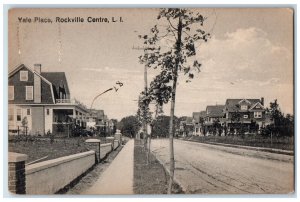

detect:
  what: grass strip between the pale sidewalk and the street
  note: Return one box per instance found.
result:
[133,140,183,194]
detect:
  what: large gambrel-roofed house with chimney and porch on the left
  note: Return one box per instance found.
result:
[8,64,88,135]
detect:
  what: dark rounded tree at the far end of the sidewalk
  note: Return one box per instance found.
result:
[118,116,141,138]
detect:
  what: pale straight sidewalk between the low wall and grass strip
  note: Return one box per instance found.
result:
[83,140,134,195]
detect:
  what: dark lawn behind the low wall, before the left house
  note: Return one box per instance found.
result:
[8,136,110,163]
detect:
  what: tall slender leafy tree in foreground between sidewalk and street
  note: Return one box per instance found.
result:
[139,8,210,194]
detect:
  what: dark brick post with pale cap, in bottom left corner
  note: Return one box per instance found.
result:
[8,152,27,194]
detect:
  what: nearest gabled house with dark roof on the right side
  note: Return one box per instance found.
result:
[224,98,266,133]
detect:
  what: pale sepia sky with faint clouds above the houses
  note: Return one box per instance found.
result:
[8,8,294,120]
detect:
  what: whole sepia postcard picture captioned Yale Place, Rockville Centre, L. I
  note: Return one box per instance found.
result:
[4,6,296,197]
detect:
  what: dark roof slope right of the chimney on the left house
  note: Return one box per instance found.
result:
[41,72,70,95]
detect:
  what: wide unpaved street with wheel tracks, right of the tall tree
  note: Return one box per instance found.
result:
[151,139,294,194]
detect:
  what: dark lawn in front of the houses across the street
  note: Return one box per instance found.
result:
[184,135,294,150]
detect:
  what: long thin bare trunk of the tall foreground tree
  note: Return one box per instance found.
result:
[168,14,182,194]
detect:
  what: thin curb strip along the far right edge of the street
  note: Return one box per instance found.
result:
[178,139,294,156]
